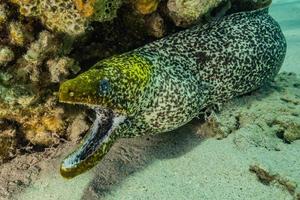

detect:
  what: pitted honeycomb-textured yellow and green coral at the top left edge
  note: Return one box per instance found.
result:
[11,0,121,36]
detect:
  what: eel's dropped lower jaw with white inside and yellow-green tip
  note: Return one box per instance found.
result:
[60,108,126,179]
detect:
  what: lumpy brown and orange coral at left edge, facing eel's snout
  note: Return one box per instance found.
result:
[0,3,80,161]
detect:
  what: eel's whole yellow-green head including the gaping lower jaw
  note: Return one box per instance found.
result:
[59,54,151,178]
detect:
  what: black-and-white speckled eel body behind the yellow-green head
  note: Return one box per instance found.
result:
[123,8,286,135]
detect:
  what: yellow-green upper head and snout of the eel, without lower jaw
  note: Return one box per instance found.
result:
[59,54,151,114]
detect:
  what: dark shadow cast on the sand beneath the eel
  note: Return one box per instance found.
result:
[82,120,203,200]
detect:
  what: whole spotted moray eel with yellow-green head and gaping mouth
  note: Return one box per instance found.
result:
[59,8,286,178]
